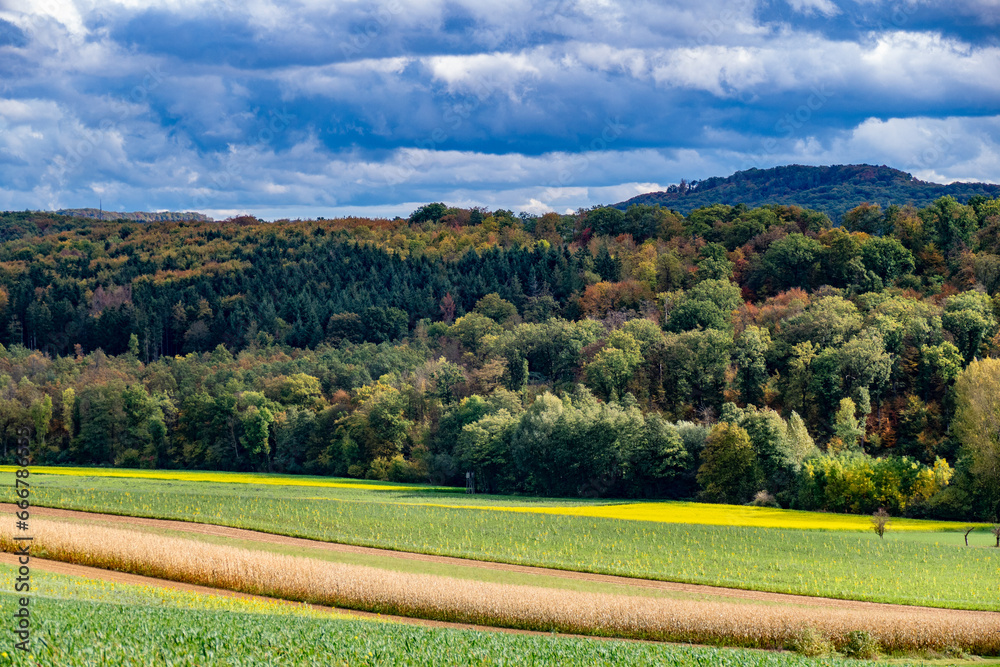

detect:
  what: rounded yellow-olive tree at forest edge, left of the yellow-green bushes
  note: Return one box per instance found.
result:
[698,422,763,503]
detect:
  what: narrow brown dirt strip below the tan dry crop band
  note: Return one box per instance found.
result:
[0,552,647,643]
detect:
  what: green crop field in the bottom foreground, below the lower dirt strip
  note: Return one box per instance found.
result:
[0,565,916,667]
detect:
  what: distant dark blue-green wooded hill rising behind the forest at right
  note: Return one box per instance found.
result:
[615,164,1000,222]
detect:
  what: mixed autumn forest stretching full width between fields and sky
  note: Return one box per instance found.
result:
[0,195,1000,520]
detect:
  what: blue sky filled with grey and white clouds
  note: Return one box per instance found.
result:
[0,0,1000,219]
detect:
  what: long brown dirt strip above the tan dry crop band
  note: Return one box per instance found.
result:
[0,503,1000,627]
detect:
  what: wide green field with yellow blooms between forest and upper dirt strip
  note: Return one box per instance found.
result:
[8,474,1000,610]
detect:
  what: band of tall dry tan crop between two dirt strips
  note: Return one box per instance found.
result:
[0,519,1000,655]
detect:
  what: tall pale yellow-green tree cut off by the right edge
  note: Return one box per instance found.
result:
[952,359,1000,521]
